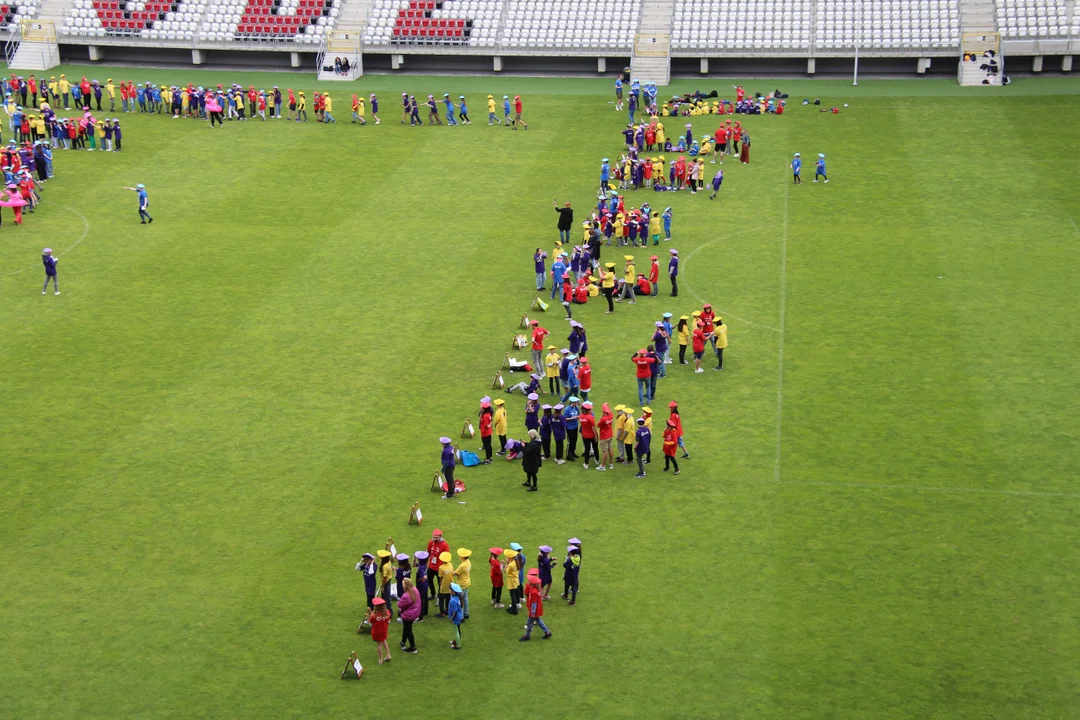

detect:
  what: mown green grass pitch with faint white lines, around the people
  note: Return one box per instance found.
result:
[0,68,1080,719]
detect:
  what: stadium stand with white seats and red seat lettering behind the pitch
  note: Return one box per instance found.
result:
[10,0,1080,76]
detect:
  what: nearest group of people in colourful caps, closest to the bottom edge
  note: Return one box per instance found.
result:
[341,528,582,678]
